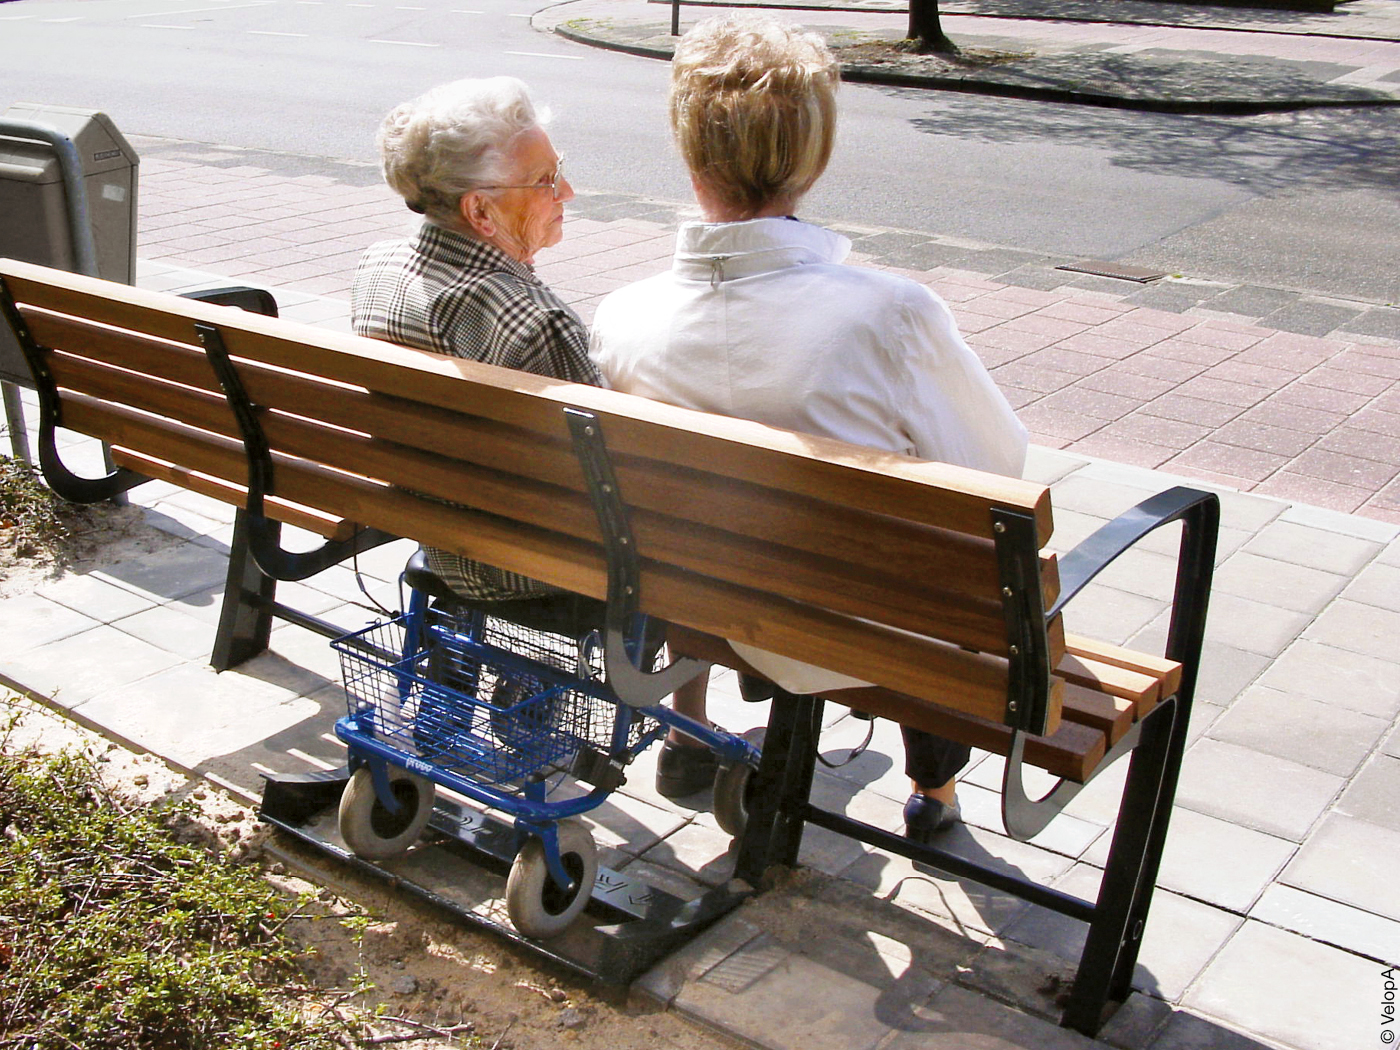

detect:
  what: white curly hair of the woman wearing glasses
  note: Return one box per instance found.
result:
[378,77,549,228]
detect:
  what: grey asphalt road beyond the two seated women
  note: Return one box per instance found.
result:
[0,0,1400,302]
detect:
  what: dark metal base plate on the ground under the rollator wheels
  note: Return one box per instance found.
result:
[259,769,752,984]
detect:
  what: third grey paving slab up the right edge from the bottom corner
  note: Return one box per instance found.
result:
[1280,815,1400,920]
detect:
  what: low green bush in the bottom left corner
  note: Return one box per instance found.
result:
[0,734,344,1050]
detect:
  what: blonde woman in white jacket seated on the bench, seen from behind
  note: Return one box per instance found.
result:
[592,15,1026,841]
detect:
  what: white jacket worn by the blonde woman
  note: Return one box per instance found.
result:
[589,218,1028,693]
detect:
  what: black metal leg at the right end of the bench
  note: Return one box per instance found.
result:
[1061,701,1180,1036]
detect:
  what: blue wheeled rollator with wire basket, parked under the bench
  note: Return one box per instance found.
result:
[332,413,759,938]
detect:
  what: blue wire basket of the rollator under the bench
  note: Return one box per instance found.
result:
[332,609,651,784]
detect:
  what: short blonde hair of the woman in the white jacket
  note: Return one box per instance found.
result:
[671,15,840,214]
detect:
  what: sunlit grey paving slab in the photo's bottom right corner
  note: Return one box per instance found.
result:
[1183,921,1382,1050]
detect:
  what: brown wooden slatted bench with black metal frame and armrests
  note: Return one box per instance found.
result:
[0,260,1218,1033]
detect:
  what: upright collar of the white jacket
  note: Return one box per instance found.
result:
[671,218,851,284]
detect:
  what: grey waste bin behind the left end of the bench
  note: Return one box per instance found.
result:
[0,102,140,386]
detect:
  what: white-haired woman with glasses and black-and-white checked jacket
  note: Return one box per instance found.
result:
[350,77,602,634]
